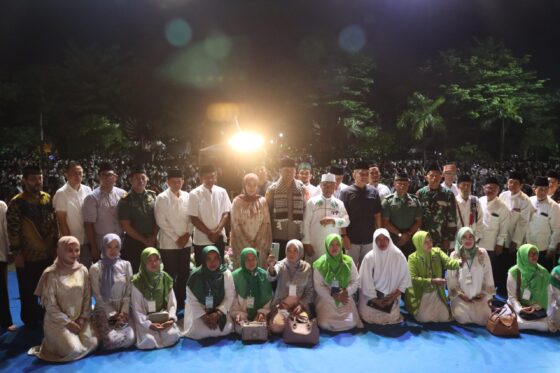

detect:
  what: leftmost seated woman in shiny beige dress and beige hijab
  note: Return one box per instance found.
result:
[28,236,97,362]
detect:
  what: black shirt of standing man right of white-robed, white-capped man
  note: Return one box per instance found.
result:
[340,184,381,245]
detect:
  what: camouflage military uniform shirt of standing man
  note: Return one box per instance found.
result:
[416,186,457,247]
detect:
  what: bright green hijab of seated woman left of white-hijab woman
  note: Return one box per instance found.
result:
[313,233,352,288]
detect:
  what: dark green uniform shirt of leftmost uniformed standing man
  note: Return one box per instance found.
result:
[117,190,156,237]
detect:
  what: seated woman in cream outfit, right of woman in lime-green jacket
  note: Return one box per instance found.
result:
[447,227,496,326]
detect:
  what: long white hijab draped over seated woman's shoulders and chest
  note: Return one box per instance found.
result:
[360,228,412,299]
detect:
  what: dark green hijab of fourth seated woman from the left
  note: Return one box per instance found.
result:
[187,246,226,307]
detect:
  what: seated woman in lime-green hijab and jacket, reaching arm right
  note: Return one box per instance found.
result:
[405,231,461,323]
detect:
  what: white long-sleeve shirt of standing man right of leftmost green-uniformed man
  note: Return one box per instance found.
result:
[154,188,193,250]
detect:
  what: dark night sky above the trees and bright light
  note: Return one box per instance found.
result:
[0,0,560,132]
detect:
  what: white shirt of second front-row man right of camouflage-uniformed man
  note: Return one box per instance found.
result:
[478,196,509,251]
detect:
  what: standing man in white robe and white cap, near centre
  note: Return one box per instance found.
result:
[302,174,350,264]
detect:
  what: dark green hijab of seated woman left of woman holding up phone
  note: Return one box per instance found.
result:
[233,247,272,320]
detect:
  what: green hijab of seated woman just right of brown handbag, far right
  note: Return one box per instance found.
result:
[508,244,550,310]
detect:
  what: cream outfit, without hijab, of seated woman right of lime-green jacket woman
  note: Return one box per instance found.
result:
[447,248,496,326]
